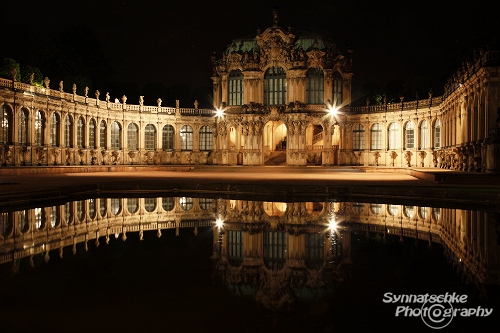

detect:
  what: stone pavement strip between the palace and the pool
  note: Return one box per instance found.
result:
[0,166,500,207]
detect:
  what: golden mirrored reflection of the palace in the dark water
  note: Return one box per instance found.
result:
[0,197,500,309]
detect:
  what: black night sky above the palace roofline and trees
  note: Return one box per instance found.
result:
[0,0,499,100]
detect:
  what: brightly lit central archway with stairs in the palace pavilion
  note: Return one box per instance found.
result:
[263,121,287,165]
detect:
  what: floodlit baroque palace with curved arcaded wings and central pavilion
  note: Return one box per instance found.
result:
[0,14,500,172]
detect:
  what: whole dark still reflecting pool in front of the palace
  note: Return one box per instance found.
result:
[0,195,500,332]
